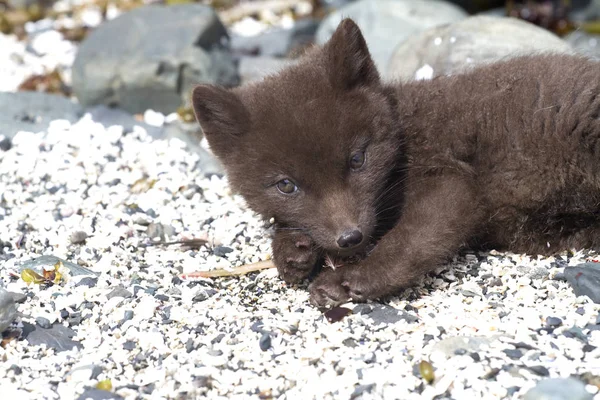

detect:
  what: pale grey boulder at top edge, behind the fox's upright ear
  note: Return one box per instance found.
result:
[315,0,467,72]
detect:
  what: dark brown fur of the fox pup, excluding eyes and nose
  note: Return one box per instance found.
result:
[193,20,600,305]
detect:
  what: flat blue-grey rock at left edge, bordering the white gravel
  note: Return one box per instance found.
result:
[0,92,83,138]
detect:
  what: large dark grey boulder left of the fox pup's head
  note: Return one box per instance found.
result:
[73,4,239,113]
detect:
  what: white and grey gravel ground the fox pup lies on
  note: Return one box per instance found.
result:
[0,12,600,400]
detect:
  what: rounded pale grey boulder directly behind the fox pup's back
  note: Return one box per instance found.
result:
[387,16,573,80]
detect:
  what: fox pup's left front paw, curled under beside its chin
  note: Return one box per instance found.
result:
[272,232,320,284]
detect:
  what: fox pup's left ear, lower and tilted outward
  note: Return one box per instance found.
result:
[192,85,250,141]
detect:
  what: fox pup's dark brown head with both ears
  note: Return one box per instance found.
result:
[193,19,403,256]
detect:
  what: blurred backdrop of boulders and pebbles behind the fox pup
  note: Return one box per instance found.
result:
[0,0,600,150]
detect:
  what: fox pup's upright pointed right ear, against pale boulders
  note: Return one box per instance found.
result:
[324,18,380,90]
